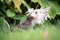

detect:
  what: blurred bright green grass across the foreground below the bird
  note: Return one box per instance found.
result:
[0,22,60,40]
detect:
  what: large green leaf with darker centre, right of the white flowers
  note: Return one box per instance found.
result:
[48,1,60,18]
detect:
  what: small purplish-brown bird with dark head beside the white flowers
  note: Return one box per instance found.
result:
[17,17,34,29]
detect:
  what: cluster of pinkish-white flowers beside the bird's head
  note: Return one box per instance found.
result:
[27,7,50,24]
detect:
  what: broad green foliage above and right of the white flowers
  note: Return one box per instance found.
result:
[31,0,60,19]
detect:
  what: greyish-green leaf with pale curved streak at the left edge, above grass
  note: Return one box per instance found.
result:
[0,17,10,31]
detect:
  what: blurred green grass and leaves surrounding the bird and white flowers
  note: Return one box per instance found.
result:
[0,0,60,40]
